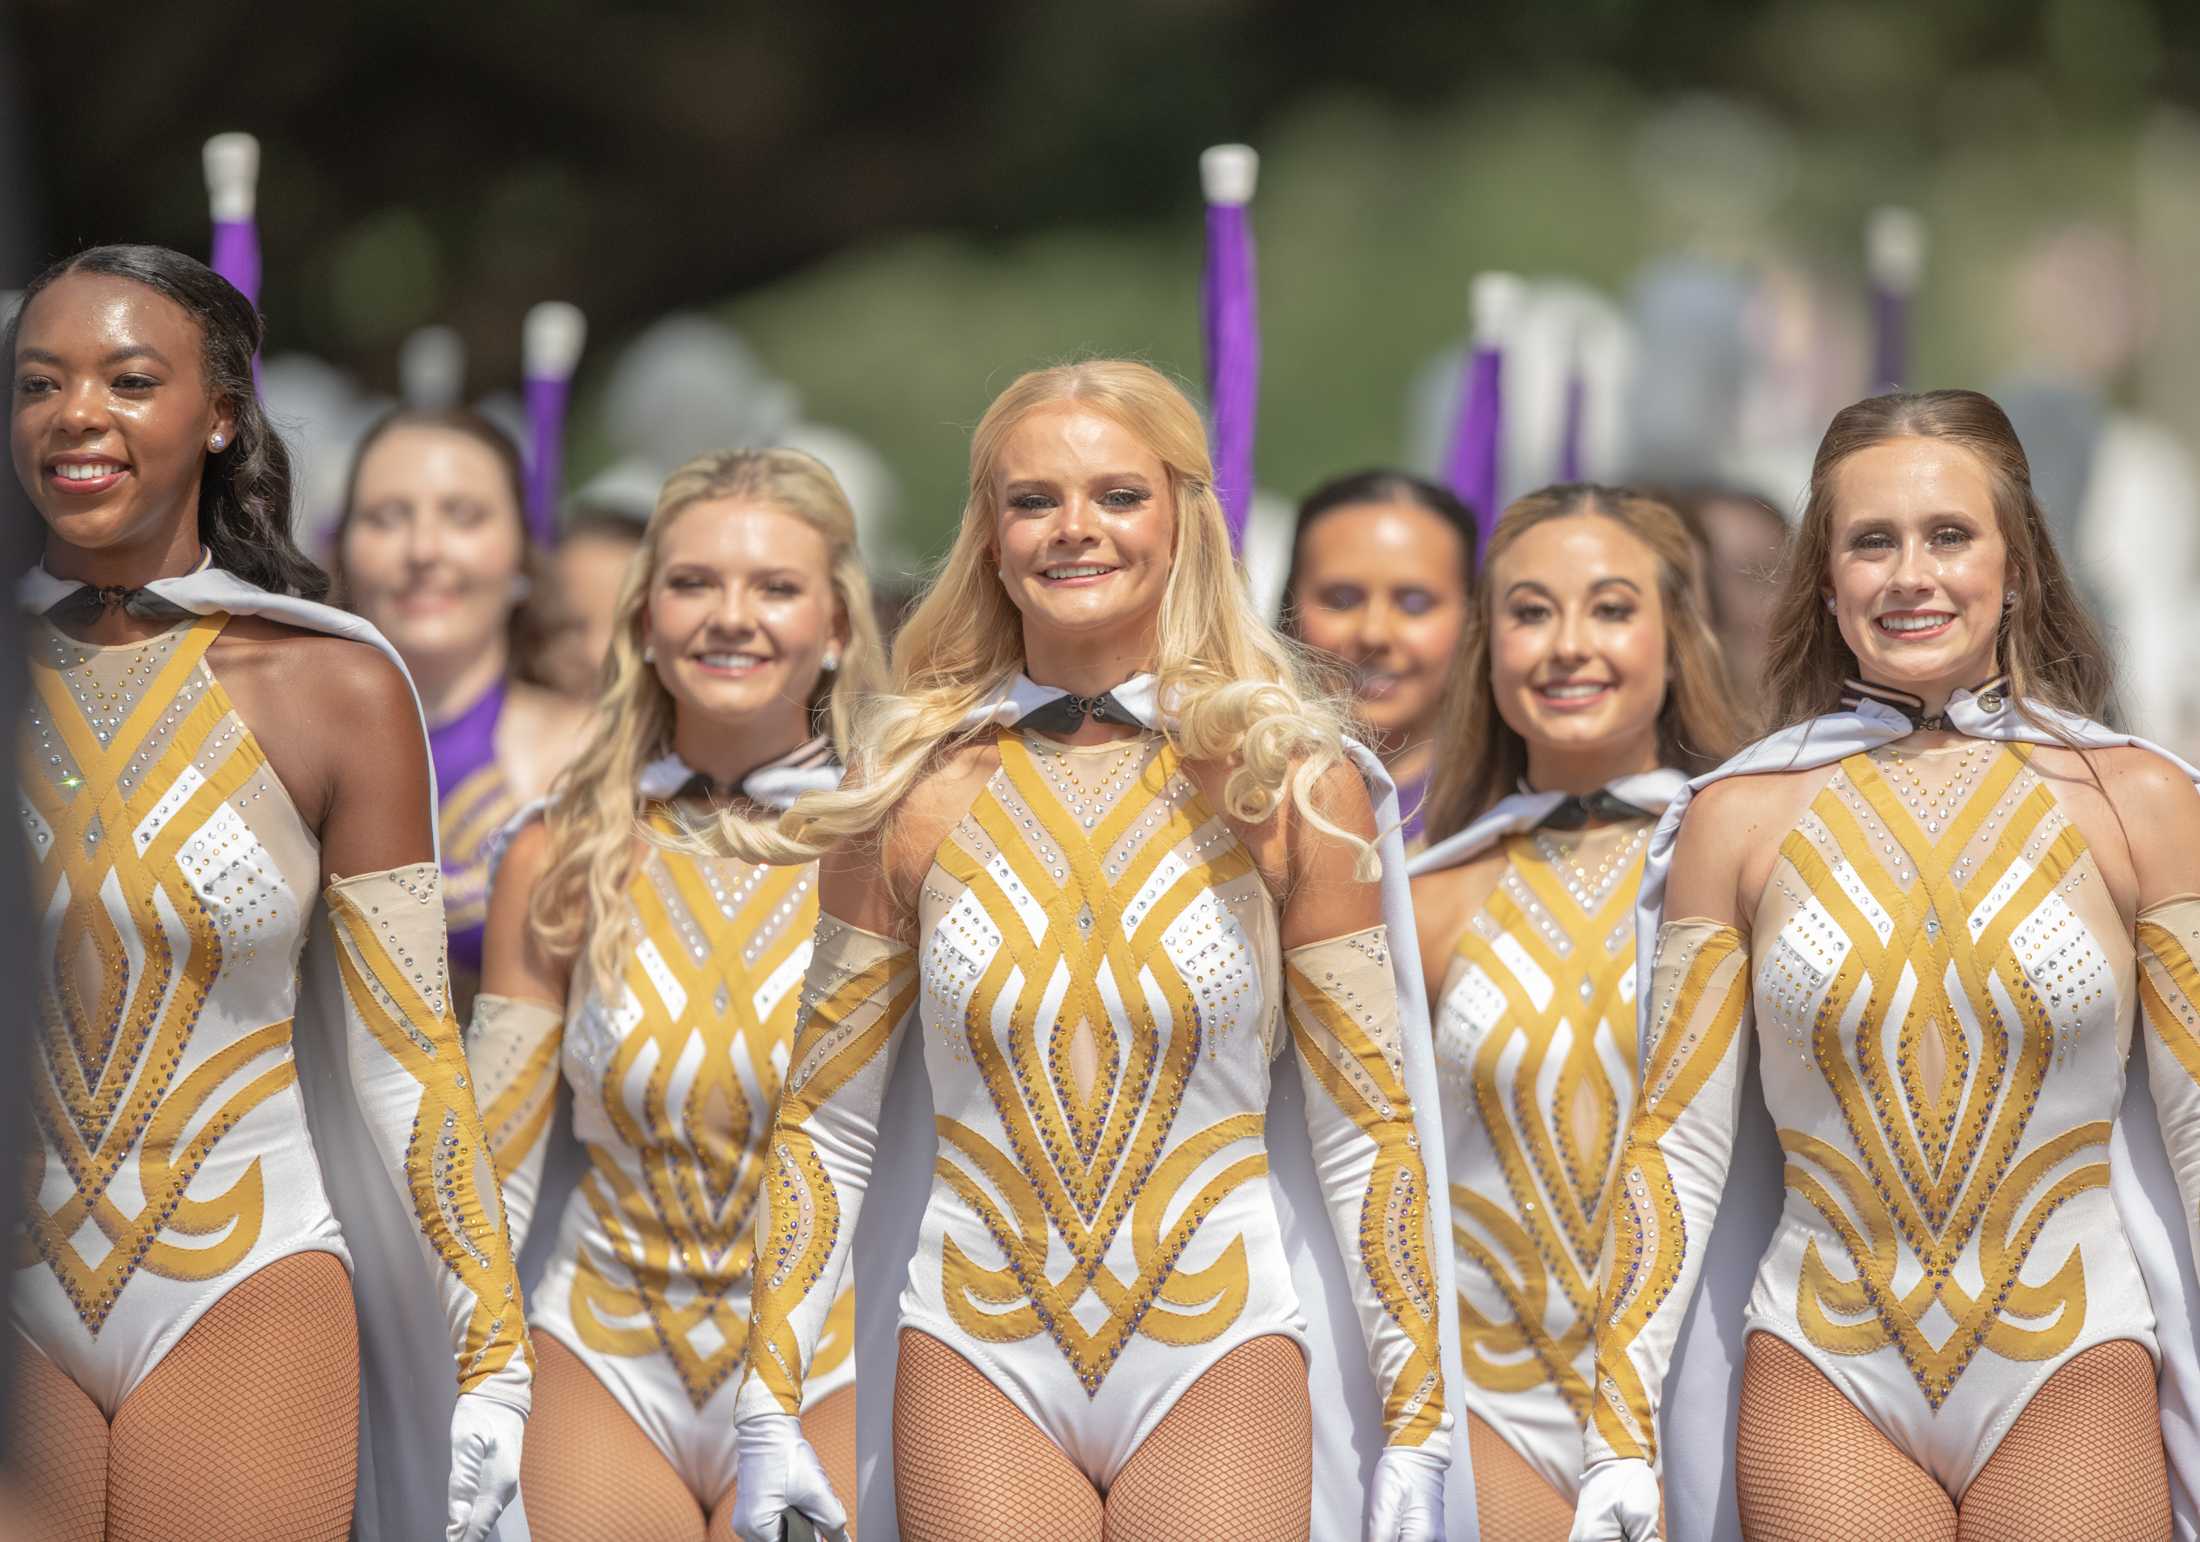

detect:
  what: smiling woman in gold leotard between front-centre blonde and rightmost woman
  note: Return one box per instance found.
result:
[1412,484,1736,1542]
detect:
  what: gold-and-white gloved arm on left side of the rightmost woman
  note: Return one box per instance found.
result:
[1573,783,1749,1542]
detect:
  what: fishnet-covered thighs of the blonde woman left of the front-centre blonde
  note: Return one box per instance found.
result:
[519,1333,856,1542]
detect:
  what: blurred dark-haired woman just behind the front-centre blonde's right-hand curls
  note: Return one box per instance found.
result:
[1280,471,1474,847]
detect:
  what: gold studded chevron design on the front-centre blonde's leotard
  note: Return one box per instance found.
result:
[937,730,1267,1392]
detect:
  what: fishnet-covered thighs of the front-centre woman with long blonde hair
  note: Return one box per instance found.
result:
[893,1331,1313,1542]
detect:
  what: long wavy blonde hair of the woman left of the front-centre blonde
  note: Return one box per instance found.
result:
[528,449,887,981]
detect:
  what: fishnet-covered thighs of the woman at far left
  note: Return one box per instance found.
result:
[9,1252,359,1542]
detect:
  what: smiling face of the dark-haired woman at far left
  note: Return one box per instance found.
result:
[9,273,235,583]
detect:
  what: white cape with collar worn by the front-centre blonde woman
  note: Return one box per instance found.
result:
[854,675,1481,1542]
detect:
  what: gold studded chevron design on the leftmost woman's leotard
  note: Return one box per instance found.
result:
[20,614,297,1333]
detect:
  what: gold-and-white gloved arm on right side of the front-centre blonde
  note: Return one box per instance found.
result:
[1283,766,1452,1542]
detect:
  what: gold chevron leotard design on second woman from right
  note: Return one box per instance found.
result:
[1448,820,1650,1423]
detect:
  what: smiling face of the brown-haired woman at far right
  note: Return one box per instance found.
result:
[1824,438,2009,711]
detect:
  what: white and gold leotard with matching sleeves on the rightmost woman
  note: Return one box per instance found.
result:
[1588,734,2200,1498]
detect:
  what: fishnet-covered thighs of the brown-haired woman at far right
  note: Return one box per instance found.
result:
[1742,1333,2169,1542]
